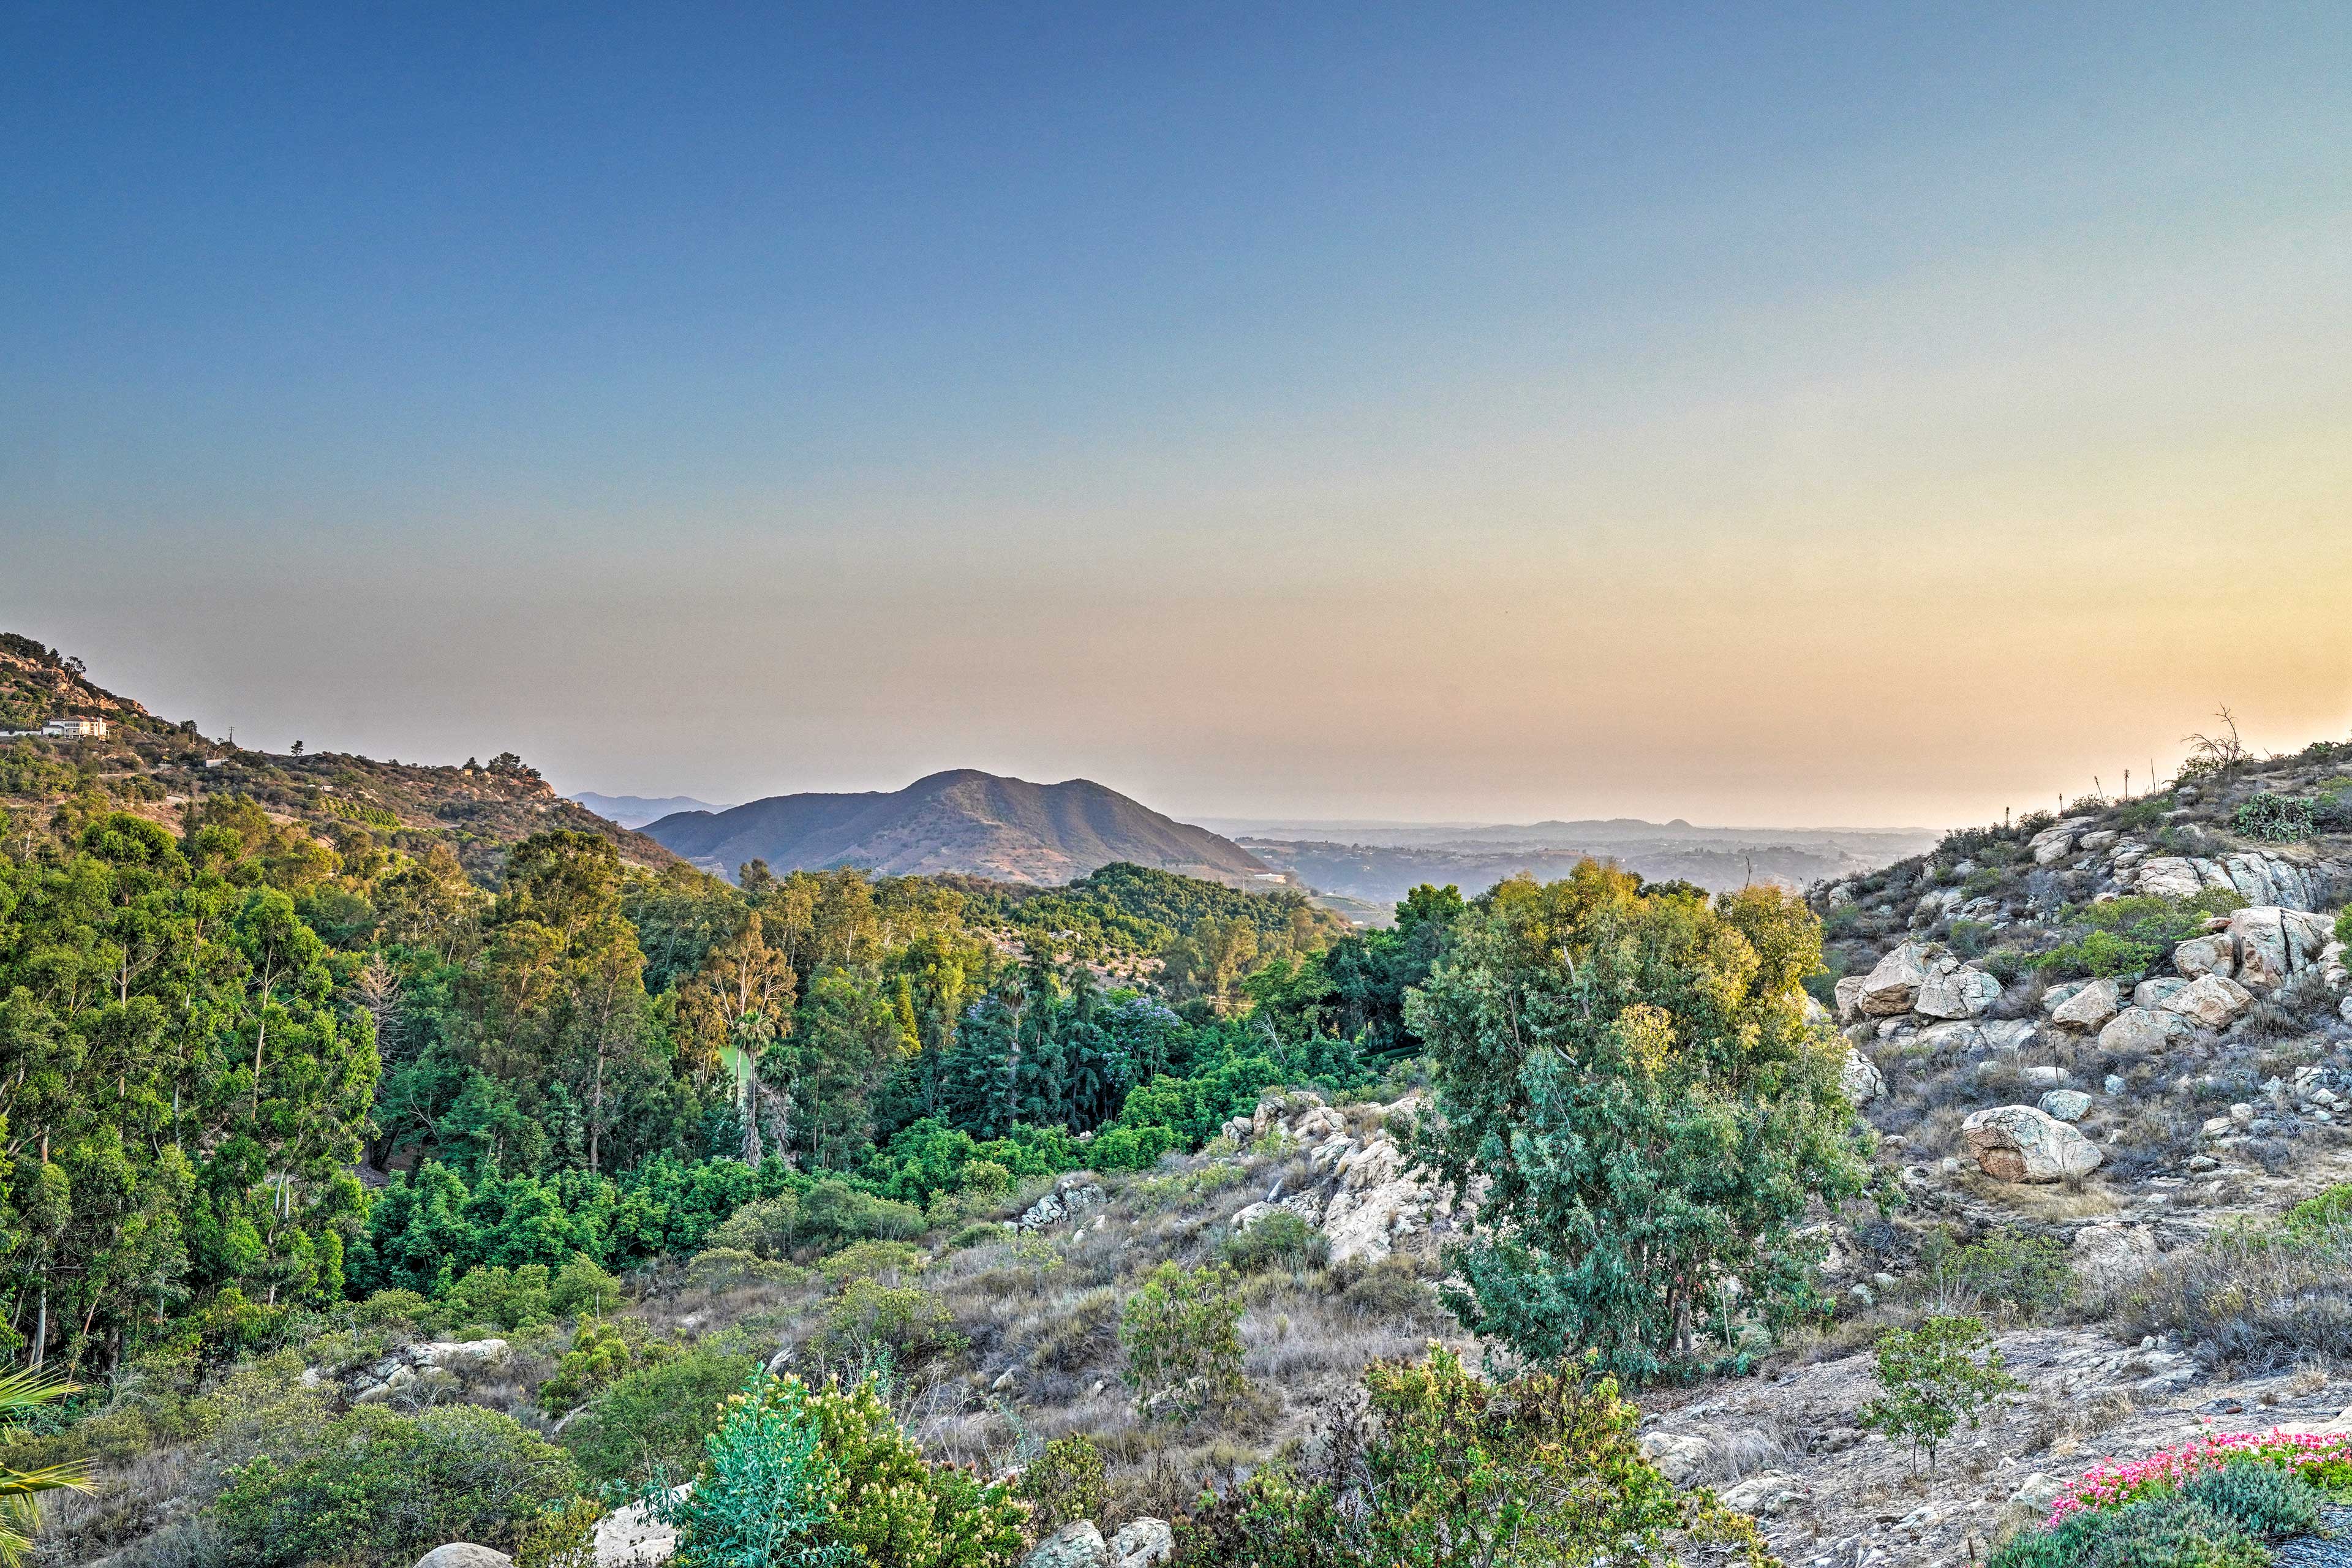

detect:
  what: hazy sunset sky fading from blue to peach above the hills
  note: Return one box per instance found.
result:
[0,0,2352,825]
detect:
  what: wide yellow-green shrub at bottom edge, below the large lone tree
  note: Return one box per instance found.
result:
[1176,1349,1771,1568]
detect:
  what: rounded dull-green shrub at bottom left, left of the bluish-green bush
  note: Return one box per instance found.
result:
[214,1406,579,1568]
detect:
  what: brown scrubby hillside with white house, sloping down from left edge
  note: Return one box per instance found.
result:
[0,632,677,884]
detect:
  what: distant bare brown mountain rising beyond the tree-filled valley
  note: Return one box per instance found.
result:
[644,769,1268,884]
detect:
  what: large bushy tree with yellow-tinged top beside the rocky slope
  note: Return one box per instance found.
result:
[1406,863,1868,1380]
